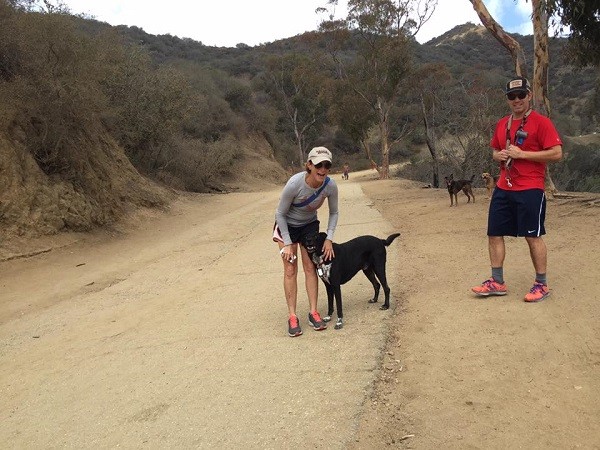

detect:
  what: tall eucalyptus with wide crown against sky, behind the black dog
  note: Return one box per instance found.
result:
[318,0,437,179]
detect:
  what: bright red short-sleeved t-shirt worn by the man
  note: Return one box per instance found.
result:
[490,111,562,191]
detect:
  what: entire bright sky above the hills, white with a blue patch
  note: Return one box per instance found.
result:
[62,0,532,47]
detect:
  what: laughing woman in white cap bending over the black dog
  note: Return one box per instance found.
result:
[273,147,338,337]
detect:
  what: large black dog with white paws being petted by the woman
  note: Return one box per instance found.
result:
[304,233,400,330]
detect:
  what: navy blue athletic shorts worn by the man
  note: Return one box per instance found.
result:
[487,187,546,237]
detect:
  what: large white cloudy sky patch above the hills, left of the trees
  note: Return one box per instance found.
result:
[64,0,345,47]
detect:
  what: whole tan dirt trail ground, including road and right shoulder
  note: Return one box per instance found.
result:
[0,172,600,449]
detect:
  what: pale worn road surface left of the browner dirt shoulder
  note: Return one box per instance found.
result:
[0,178,400,448]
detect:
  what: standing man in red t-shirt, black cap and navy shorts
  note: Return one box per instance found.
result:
[471,77,562,302]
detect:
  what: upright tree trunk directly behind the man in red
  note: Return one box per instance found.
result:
[531,0,558,199]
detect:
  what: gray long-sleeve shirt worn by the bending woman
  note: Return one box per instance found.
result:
[275,172,338,245]
